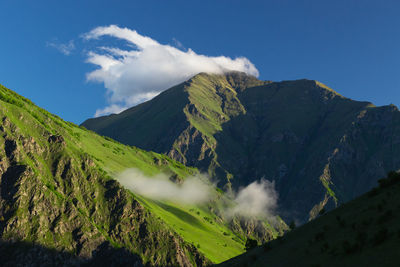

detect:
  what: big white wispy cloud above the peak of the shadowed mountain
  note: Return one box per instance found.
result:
[83,25,258,116]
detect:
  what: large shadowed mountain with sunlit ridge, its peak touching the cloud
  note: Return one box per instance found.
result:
[82,72,400,222]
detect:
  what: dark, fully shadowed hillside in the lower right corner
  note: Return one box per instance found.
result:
[218,172,400,267]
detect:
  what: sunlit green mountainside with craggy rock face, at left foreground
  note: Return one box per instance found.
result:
[0,83,287,266]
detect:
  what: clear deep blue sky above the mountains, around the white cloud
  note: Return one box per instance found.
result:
[0,0,400,123]
